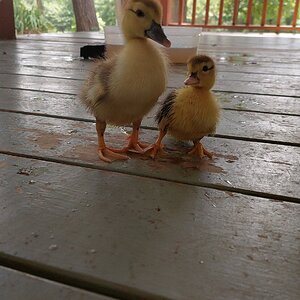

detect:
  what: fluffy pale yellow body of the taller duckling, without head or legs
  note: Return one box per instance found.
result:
[81,39,167,126]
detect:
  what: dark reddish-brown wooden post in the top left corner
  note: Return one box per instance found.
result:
[0,0,16,40]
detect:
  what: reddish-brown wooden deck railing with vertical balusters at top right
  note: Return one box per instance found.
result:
[161,0,300,32]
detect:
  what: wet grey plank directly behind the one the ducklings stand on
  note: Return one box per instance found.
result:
[0,90,300,145]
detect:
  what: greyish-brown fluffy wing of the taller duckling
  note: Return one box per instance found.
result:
[80,59,116,112]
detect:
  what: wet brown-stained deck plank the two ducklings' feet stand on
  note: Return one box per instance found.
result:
[0,113,300,202]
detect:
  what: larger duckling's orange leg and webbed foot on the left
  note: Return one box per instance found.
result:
[96,119,129,163]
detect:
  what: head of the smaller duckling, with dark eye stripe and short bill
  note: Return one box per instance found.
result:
[184,55,216,90]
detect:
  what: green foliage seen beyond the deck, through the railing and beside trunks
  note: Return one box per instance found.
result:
[14,0,295,33]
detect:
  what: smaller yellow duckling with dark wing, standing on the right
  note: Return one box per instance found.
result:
[145,55,220,158]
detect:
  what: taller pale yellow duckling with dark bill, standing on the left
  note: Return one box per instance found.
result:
[81,0,171,162]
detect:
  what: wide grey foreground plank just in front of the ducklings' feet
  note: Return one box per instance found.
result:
[0,152,300,300]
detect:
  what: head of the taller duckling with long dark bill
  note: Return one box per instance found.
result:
[122,0,171,47]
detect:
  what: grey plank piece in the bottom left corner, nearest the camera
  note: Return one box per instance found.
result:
[0,266,113,300]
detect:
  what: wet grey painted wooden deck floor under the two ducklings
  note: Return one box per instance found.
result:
[0,33,300,300]
